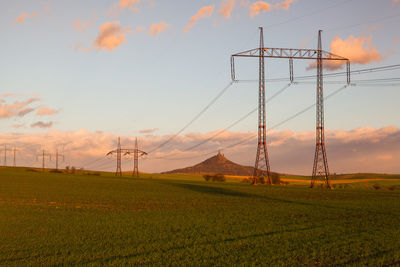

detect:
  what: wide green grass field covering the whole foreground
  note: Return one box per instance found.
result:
[0,168,400,266]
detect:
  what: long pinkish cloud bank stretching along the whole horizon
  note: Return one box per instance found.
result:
[0,127,400,175]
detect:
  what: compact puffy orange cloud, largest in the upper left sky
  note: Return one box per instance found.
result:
[93,21,130,51]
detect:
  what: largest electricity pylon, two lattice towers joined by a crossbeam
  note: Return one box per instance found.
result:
[231,27,350,188]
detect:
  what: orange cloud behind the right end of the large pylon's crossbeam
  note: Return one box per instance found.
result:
[308,35,383,70]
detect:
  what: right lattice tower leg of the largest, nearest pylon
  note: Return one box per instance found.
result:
[311,30,331,188]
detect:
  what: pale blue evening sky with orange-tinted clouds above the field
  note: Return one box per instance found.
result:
[0,0,400,174]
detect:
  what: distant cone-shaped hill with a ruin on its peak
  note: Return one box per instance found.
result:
[164,152,254,176]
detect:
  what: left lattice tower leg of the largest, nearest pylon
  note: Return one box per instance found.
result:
[253,27,271,184]
